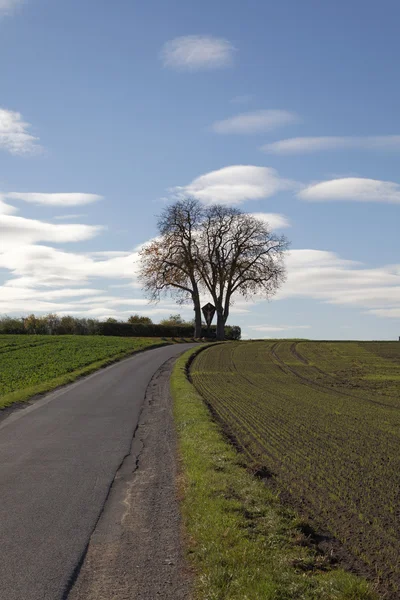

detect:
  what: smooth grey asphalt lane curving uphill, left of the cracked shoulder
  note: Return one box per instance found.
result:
[0,344,193,600]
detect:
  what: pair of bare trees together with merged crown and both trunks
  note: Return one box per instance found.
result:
[140,198,289,339]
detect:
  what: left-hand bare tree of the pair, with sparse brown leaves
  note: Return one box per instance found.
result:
[140,198,204,337]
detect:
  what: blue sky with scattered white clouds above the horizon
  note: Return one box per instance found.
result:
[0,0,400,340]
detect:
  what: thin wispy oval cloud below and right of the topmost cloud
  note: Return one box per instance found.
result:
[212,110,299,133]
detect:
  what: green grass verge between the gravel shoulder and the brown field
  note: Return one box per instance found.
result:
[171,350,376,600]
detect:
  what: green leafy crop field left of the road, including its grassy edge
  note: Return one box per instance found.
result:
[0,335,165,408]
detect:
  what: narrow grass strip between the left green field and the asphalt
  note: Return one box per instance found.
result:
[0,340,172,410]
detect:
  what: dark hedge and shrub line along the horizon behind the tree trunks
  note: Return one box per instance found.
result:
[0,313,241,340]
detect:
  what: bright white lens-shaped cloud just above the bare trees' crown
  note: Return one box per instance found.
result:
[174,165,294,204]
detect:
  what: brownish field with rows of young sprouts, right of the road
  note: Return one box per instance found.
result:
[191,340,400,599]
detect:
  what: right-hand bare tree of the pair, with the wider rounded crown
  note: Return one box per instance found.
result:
[195,205,289,340]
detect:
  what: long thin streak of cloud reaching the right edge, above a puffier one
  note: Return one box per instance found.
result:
[262,135,400,154]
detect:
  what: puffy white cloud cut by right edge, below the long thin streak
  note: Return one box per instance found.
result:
[297,177,400,204]
